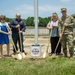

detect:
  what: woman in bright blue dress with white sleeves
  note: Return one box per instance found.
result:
[0,15,10,58]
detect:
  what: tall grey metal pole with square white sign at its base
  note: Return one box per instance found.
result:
[30,0,41,57]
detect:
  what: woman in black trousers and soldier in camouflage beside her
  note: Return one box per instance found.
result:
[47,8,75,58]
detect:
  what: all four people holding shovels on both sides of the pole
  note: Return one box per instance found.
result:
[0,8,75,58]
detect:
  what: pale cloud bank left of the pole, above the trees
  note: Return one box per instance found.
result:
[0,4,34,18]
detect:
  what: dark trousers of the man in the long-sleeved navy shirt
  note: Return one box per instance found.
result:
[12,33,24,53]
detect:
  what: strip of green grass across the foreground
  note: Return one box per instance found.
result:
[0,57,75,75]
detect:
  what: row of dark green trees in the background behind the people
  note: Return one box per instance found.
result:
[6,16,51,27]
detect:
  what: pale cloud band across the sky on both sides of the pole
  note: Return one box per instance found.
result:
[0,0,74,18]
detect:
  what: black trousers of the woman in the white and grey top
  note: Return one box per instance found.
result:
[51,37,61,54]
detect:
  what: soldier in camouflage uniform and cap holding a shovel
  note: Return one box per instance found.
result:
[59,8,74,57]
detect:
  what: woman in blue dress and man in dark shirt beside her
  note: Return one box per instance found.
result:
[0,14,26,58]
